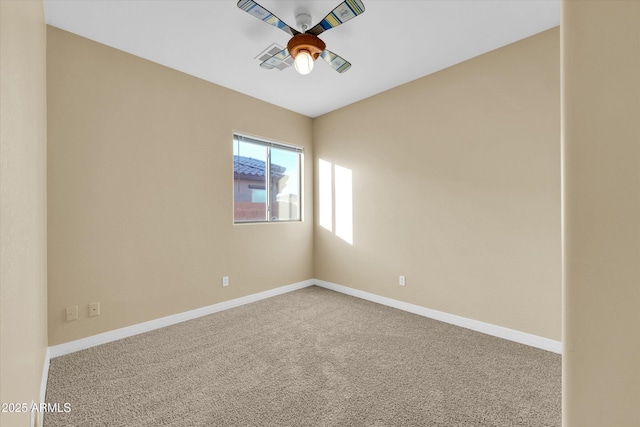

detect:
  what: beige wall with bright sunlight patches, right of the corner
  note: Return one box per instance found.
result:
[314,28,561,340]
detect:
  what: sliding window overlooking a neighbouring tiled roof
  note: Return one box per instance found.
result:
[233,134,302,223]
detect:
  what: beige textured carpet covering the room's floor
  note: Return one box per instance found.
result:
[45,286,561,427]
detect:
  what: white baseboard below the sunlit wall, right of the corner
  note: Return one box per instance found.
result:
[314,279,562,354]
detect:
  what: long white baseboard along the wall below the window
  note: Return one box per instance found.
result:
[45,279,315,360]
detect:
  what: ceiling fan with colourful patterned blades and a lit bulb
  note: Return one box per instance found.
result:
[238,0,364,74]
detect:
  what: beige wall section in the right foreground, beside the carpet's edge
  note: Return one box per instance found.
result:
[562,1,640,427]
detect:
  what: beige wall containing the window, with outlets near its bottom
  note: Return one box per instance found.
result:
[47,27,313,345]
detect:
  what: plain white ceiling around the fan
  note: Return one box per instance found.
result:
[44,0,560,117]
